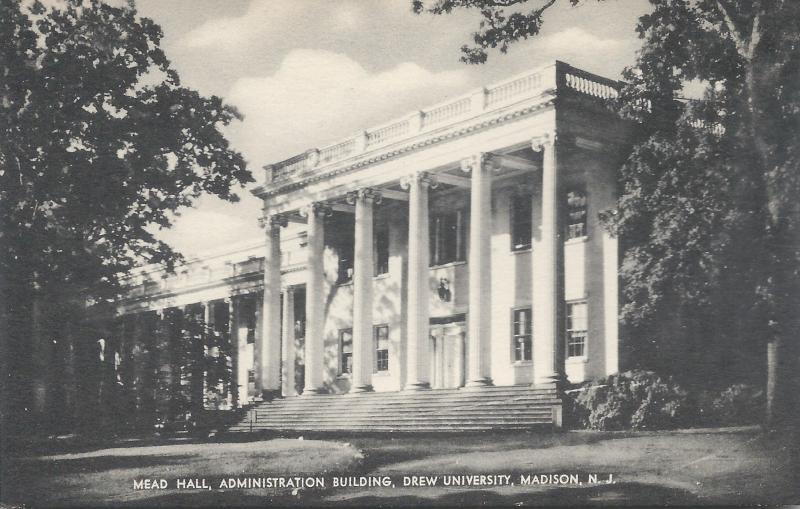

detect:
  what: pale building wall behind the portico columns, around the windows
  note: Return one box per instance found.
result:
[310,156,616,386]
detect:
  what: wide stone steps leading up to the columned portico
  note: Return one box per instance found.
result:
[227,386,561,432]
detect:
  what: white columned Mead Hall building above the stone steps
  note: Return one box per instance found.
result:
[121,62,629,428]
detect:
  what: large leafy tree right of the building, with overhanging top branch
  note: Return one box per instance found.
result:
[412,0,800,422]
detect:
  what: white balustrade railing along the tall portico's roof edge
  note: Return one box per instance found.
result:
[265,62,619,185]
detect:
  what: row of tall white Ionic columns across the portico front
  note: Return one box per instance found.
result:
[255,134,563,396]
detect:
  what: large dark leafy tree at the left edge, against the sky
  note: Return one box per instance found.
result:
[0,0,252,434]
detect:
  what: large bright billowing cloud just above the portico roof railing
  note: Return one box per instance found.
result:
[226,49,468,166]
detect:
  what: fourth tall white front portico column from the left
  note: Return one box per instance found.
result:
[401,172,436,390]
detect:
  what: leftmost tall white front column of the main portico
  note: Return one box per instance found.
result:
[256,215,286,395]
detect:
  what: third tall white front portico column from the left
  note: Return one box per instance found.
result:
[348,188,381,392]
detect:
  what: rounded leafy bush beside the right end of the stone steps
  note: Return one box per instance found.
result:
[566,371,691,430]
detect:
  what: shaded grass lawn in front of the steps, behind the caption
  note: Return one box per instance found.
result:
[2,428,800,507]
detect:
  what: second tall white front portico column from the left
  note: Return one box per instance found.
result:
[302,203,330,395]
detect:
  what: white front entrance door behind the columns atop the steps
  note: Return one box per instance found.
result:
[430,322,466,389]
